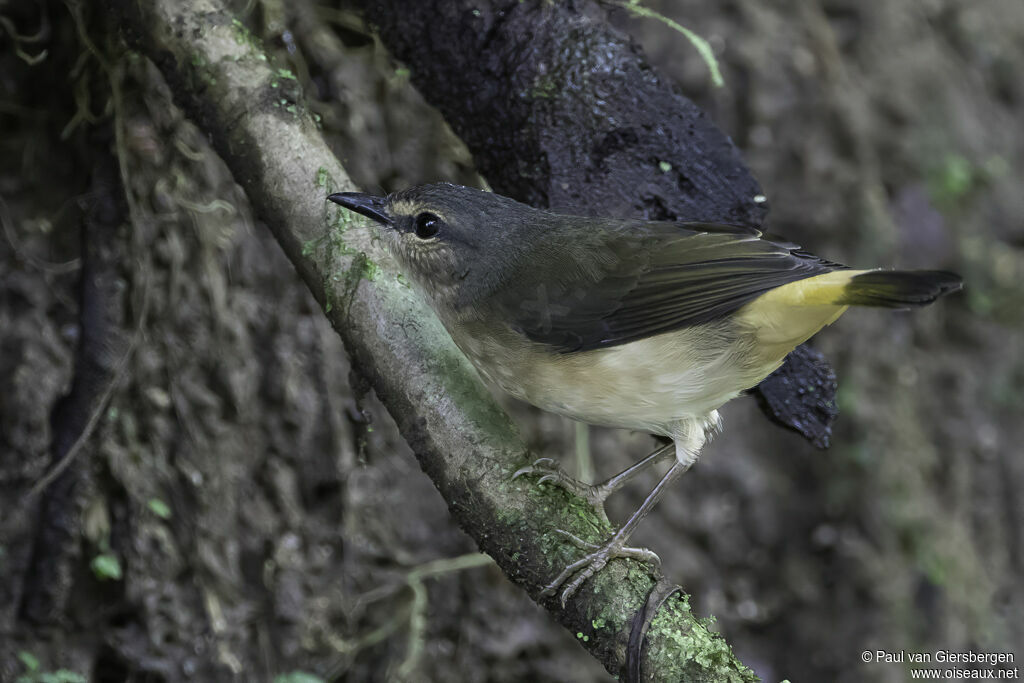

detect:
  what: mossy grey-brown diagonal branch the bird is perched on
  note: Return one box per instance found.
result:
[108,0,754,681]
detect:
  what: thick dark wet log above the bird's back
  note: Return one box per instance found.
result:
[356,0,766,225]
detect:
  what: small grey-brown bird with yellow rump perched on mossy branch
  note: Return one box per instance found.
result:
[328,183,962,604]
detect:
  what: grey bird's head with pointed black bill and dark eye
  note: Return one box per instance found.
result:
[328,183,549,308]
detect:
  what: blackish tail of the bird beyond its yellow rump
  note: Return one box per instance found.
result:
[836,270,964,308]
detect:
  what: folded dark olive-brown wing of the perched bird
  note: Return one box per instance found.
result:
[489,222,843,352]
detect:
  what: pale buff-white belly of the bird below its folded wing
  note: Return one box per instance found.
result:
[457,323,774,435]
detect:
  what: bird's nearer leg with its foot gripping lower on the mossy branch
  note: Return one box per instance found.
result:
[542,452,695,607]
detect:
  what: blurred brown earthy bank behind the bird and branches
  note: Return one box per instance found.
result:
[0,0,1024,683]
